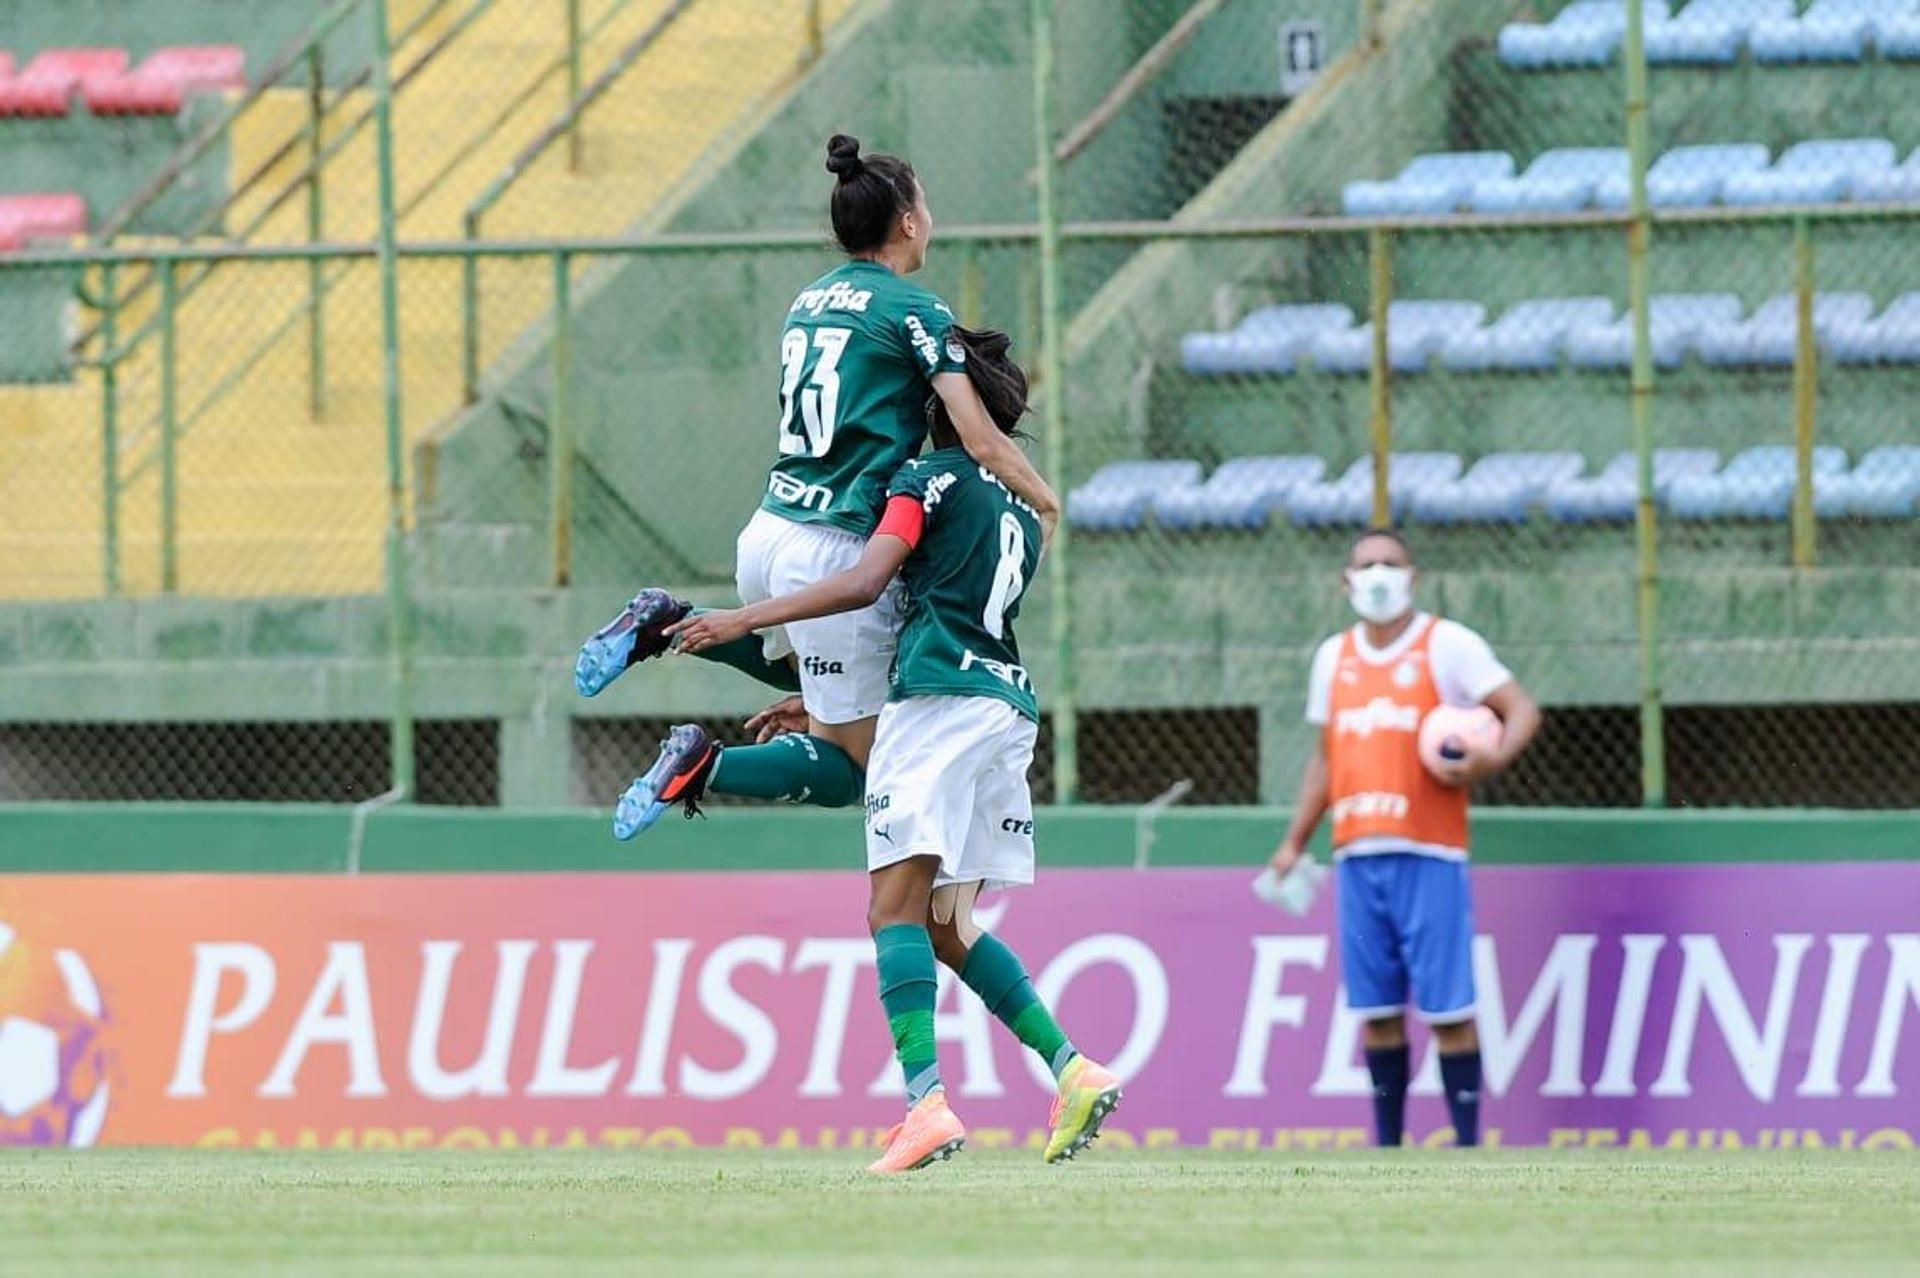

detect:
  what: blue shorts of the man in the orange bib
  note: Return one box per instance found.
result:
[1340,852,1473,1025]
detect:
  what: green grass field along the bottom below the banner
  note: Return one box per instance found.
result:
[0,1151,1920,1278]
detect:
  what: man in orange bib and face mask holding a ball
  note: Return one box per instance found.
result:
[1273,530,1540,1146]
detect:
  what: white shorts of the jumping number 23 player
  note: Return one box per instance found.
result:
[733,510,902,723]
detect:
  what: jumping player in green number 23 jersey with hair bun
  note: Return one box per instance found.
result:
[574,134,1060,839]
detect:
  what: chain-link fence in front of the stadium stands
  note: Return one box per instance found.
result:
[0,0,1920,806]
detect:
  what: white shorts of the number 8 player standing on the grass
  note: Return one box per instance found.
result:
[866,697,1039,890]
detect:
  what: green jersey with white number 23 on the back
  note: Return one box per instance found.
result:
[760,261,966,537]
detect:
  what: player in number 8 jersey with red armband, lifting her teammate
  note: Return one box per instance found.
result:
[668,328,1119,1172]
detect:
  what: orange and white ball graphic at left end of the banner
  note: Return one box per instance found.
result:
[0,921,109,1146]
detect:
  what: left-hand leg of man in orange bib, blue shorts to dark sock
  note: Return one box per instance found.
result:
[1336,854,1413,1148]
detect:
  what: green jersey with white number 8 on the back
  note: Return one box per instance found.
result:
[887,449,1041,720]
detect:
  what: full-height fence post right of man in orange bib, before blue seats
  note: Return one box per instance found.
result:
[1626,0,1667,808]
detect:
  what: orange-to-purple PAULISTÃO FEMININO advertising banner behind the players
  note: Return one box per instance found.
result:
[0,864,1920,1149]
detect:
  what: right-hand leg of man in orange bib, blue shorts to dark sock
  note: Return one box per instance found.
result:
[1400,856,1480,1146]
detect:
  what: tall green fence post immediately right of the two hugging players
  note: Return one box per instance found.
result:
[1031,0,1079,804]
